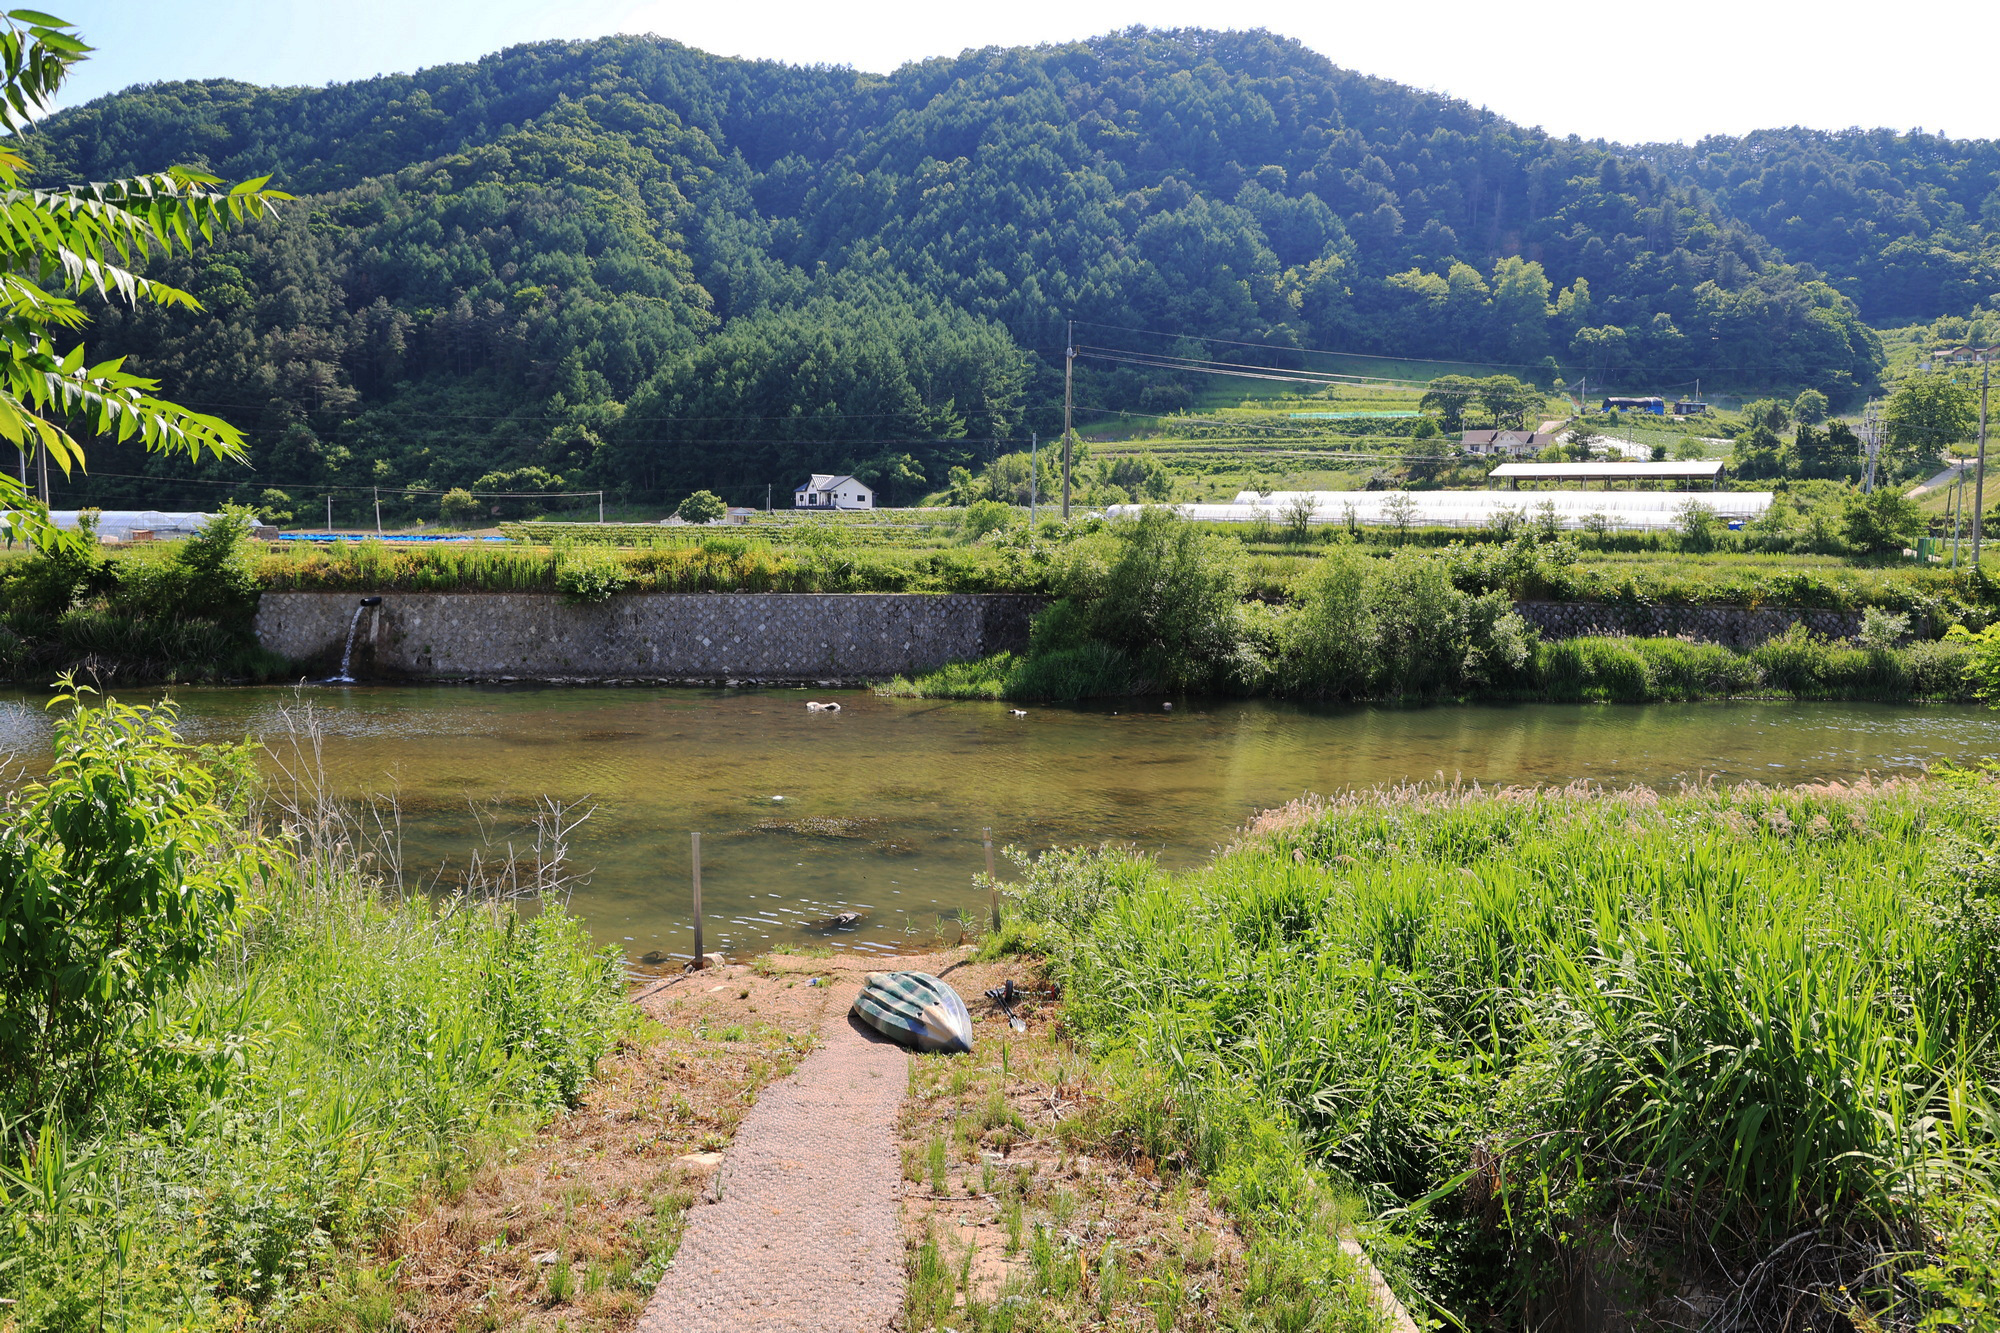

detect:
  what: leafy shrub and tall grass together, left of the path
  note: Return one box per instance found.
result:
[0,695,628,1333]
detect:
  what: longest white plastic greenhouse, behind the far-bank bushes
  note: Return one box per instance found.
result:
[1104,490,1772,530]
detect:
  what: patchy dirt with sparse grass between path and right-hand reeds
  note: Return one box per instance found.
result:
[902,948,1296,1333]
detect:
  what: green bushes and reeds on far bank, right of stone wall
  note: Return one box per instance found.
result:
[884,510,1990,703]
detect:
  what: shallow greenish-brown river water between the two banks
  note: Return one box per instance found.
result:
[0,687,2000,957]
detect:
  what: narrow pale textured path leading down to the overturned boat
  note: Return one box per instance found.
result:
[638,983,910,1333]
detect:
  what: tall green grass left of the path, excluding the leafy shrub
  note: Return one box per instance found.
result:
[0,700,626,1333]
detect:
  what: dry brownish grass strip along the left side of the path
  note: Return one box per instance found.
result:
[294,961,828,1333]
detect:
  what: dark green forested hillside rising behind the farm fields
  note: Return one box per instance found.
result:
[30,30,2000,502]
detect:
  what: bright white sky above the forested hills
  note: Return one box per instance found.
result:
[40,0,2000,142]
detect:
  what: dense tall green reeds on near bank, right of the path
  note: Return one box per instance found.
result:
[1000,775,2000,1329]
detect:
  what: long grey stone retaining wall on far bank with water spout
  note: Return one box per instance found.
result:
[256,592,1042,685]
